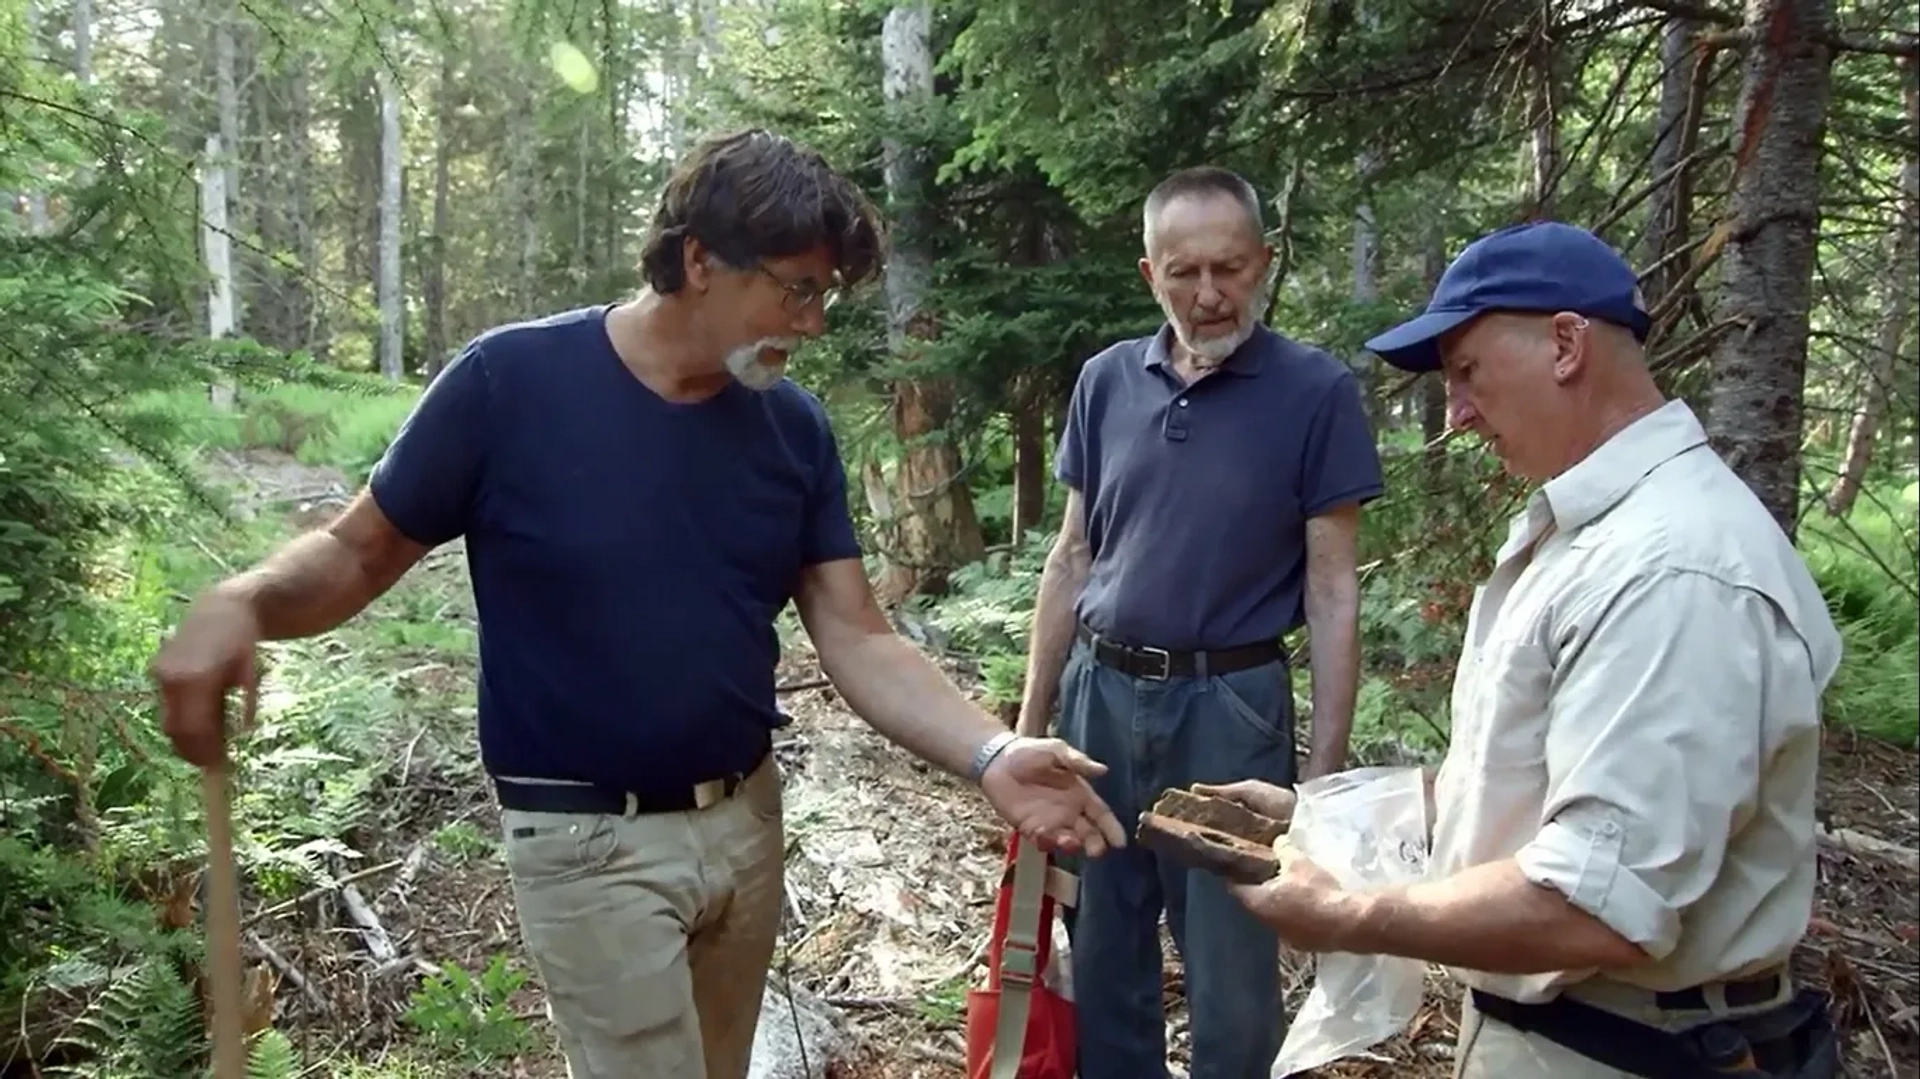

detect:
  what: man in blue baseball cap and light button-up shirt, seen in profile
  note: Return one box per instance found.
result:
[1205,223,1839,1079]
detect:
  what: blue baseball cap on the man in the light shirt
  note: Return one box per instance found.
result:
[1367,221,1651,371]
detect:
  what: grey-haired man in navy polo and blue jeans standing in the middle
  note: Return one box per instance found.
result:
[1020,169,1382,1079]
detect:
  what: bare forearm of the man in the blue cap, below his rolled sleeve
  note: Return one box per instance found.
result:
[1338,858,1647,973]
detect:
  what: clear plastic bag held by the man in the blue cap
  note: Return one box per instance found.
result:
[1273,768,1430,1079]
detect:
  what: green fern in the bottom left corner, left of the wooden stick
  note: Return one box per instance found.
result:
[48,958,205,1079]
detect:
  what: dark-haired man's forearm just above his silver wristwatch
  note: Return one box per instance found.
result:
[820,634,1004,778]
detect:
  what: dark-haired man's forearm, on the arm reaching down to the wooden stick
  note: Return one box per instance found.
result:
[215,530,394,641]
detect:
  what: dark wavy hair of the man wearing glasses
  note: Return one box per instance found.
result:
[639,129,885,296]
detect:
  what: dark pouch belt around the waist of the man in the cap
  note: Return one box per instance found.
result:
[1473,989,1839,1079]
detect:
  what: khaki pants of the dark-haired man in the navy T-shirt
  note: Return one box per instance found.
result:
[501,755,785,1079]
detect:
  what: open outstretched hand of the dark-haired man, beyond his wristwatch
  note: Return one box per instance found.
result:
[979,737,1127,858]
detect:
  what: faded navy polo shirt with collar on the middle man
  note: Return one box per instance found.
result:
[1054,324,1384,651]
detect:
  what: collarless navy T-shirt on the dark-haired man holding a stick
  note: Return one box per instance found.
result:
[371,307,860,791]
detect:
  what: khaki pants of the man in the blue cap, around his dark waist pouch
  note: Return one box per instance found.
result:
[1453,977,1793,1079]
